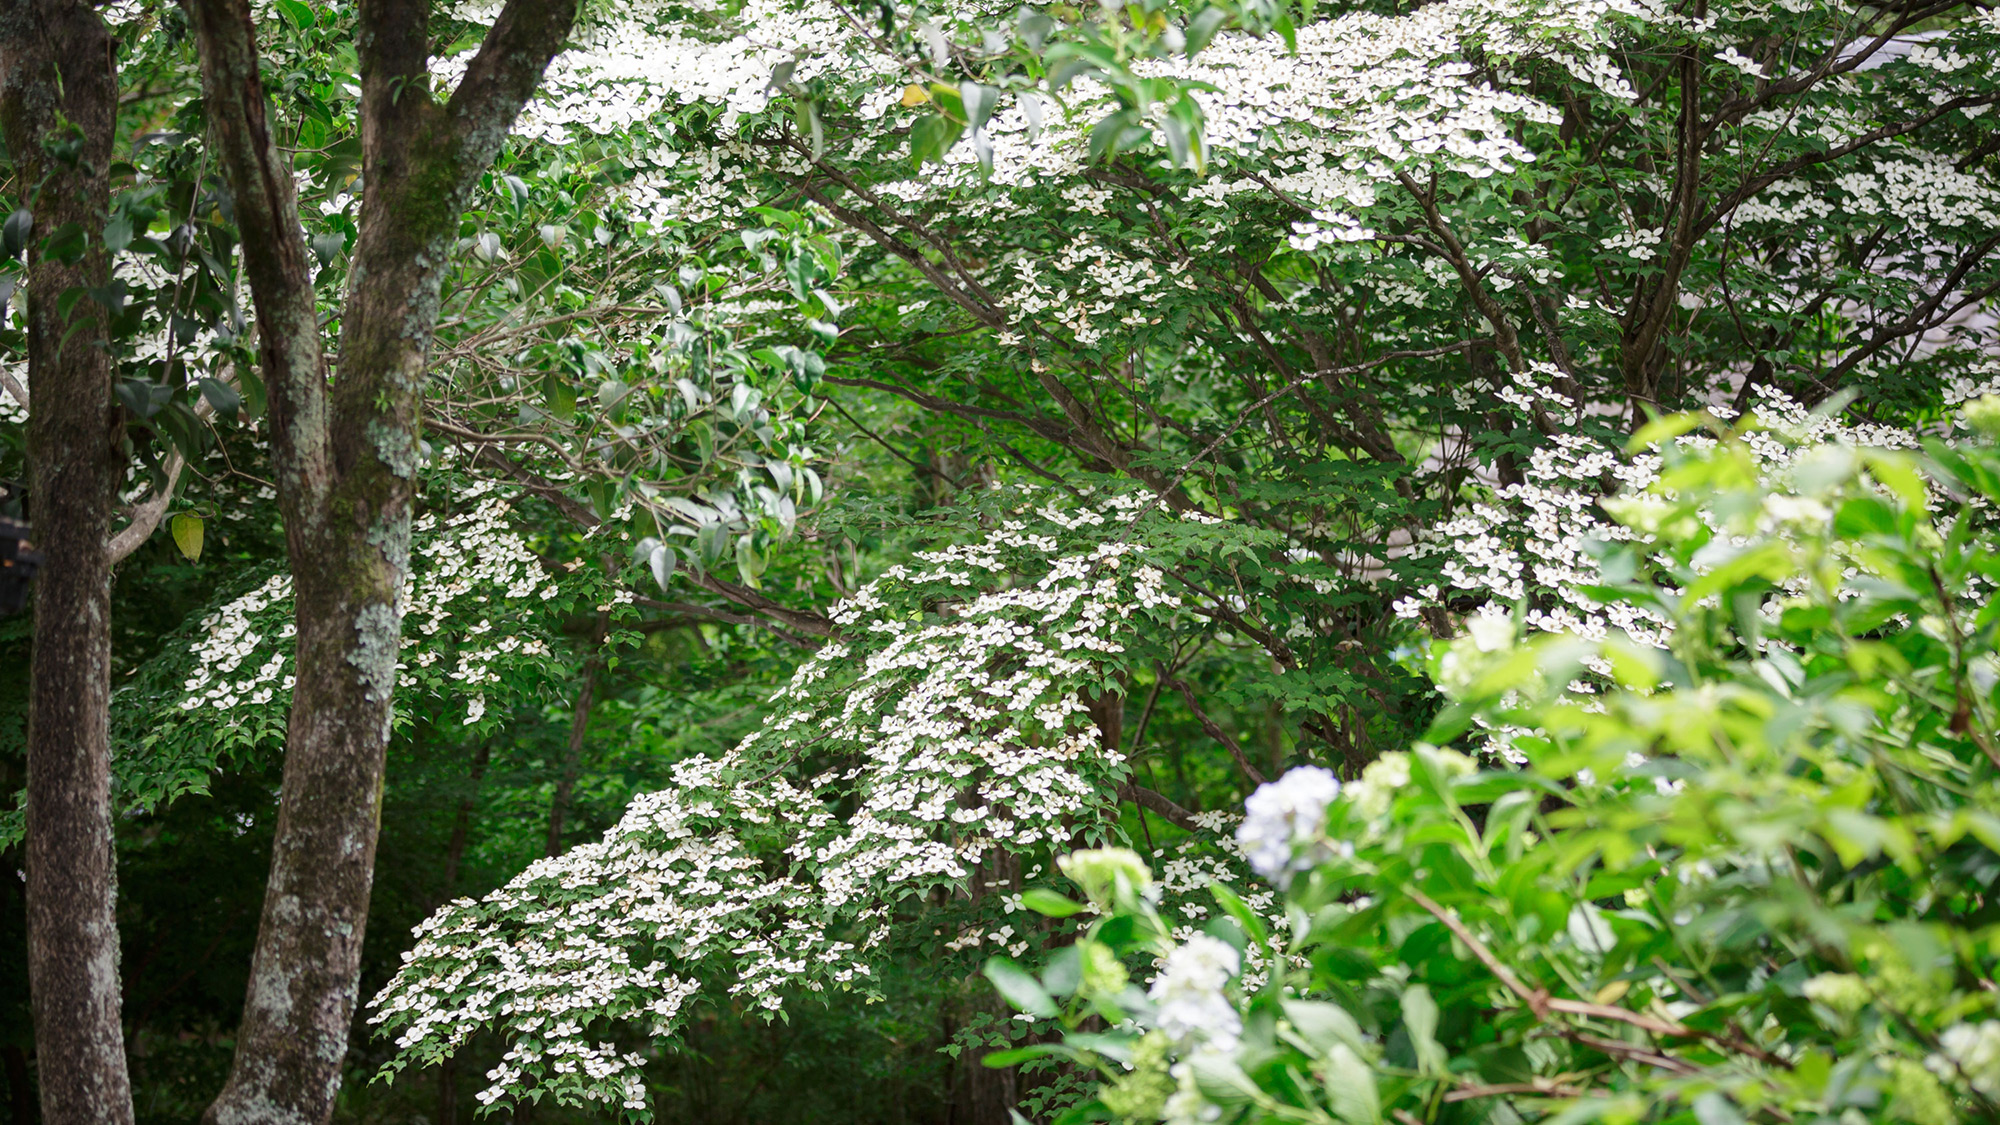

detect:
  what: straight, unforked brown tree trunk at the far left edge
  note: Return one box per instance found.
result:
[0,0,132,1125]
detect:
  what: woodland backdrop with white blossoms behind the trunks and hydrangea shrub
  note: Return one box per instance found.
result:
[0,0,2000,1123]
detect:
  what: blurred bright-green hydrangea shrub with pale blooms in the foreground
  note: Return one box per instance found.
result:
[988,398,2000,1125]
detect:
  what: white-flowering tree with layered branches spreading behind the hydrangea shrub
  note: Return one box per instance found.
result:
[3,0,2000,1103]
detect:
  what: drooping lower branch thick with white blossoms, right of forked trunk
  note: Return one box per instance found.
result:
[374,494,1224,1099]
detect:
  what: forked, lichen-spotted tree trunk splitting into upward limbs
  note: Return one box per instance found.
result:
[186,0,576,1125]
